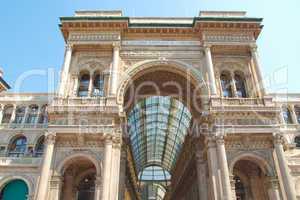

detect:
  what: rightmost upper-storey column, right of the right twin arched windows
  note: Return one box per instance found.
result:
[250,45,266,97]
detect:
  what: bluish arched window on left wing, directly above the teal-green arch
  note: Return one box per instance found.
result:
[8,136,27,157]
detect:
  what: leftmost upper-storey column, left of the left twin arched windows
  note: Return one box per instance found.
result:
[59,44,72,96]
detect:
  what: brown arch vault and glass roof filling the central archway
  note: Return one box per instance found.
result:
[122,65,205,200]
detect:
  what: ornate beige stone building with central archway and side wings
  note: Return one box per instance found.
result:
[0,11,300,200]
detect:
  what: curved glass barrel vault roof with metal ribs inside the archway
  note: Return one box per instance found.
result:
[128,96,191,173]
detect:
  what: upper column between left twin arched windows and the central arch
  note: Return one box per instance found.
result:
[109,43,120,95]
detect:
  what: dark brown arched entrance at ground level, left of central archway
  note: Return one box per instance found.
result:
[61,157,96,200]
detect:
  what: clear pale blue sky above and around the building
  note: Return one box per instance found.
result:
[0,0,300,93]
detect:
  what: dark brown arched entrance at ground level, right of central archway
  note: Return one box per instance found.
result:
[233,160,269,200]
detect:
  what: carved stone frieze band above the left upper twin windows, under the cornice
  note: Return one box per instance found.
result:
[68,32,121,44]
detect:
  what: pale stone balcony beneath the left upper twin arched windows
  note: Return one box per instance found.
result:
[48,97,118,113]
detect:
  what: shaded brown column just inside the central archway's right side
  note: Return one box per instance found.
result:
[196,152,208,200]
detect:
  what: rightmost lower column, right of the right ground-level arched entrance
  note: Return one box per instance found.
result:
[274,134,296,200]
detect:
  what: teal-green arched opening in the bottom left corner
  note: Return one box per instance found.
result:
[0,179,28,200]
